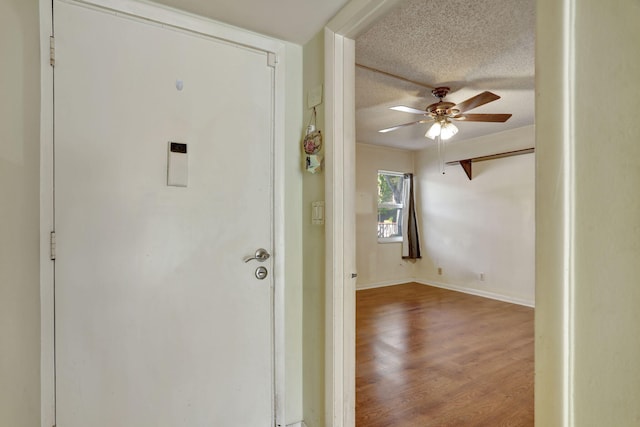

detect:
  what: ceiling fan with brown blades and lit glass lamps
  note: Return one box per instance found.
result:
[378,87,511,140]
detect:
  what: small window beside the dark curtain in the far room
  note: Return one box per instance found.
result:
[378,171,404,243]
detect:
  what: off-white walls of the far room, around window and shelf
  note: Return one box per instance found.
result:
[356,126,535,306]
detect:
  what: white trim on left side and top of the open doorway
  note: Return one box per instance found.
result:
[324,0,399,427]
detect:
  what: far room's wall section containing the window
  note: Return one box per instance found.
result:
[356,144,415,289]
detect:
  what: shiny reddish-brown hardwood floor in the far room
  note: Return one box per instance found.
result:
[356,283,534,427]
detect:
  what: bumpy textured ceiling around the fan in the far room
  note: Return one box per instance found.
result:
[356,0,535,150]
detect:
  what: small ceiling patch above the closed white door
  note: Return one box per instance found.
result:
[149,0,348,44]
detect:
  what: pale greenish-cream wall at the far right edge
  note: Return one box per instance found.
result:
[573,0,640,425]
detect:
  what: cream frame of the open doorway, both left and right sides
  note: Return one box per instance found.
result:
[324,0,577,427]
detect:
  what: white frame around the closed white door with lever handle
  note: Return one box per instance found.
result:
[39,0,286,427]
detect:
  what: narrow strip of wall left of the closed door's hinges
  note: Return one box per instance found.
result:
[0,0,40,427]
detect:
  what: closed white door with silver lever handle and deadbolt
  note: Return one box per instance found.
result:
[54,0,274,427]
